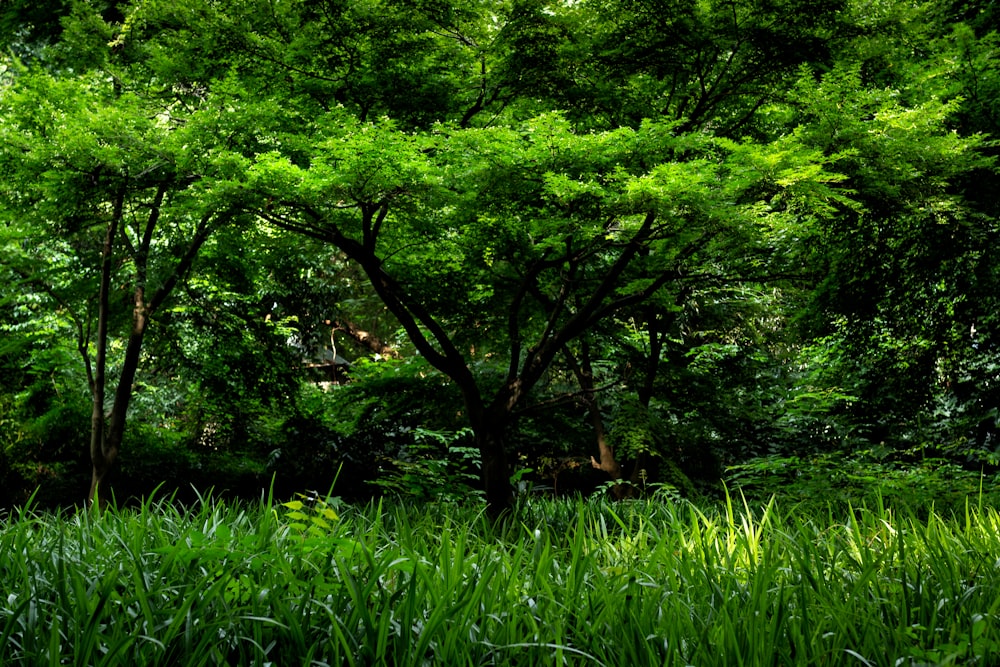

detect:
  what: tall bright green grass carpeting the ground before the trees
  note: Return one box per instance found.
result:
[0,500,1000,667]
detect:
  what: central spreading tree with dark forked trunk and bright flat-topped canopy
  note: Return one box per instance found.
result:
[249,108,852,510]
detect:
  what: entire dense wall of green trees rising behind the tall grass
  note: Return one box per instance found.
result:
[0,0,1000,511]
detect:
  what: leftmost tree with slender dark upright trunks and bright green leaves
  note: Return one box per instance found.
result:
[0,39,256,501]
